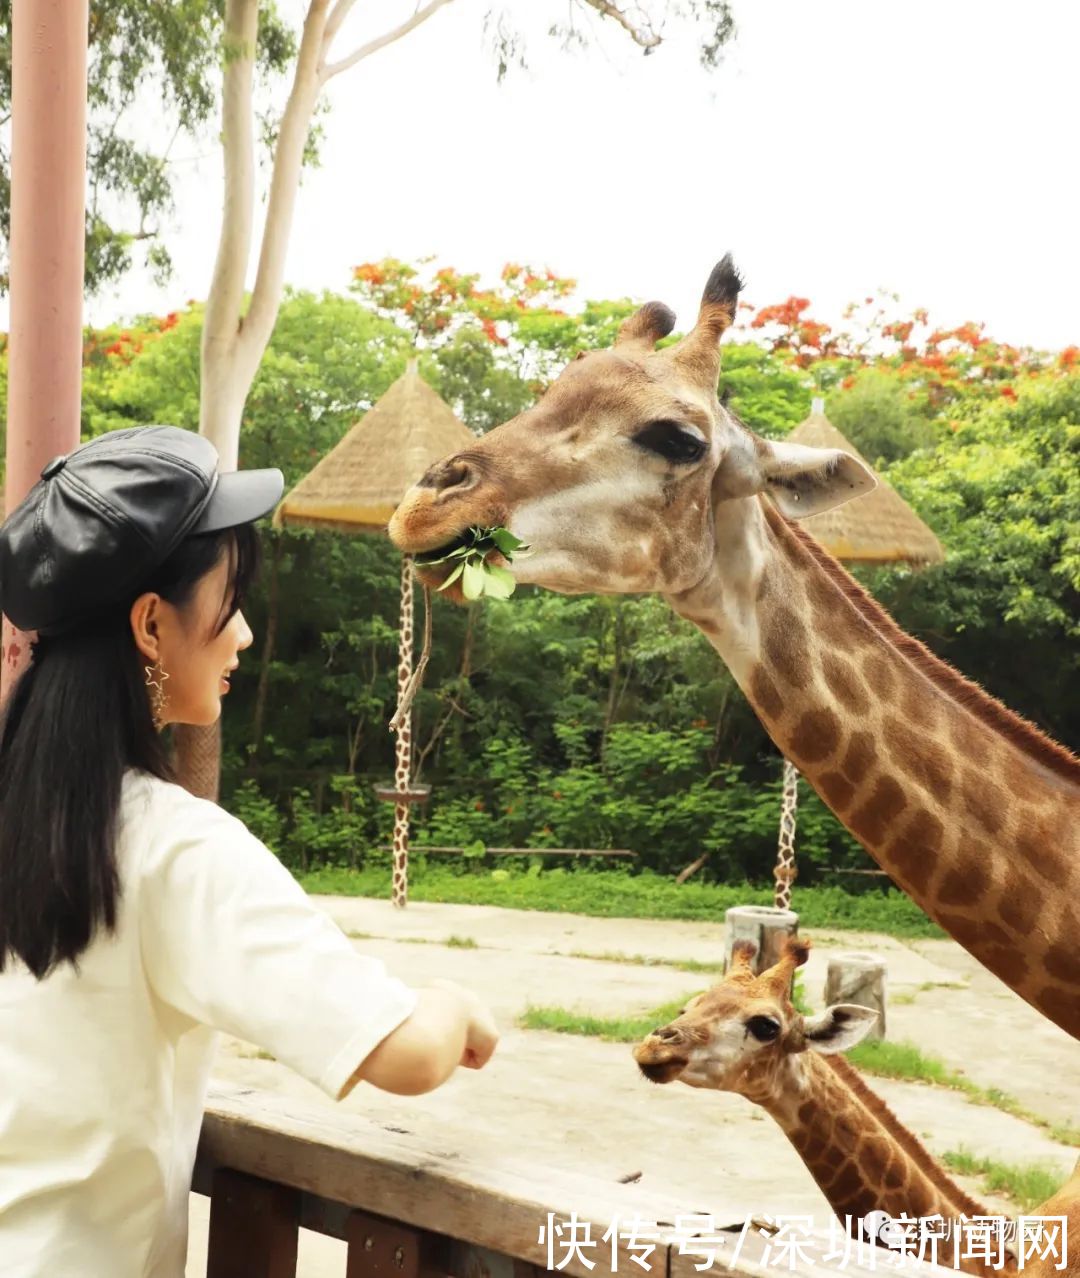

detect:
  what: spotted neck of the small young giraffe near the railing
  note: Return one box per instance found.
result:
[739,1052,1001,1274]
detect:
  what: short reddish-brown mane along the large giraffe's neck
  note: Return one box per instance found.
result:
[763,502,1080,786]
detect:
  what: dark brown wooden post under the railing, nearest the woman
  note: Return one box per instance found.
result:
[206,1168,300,1278]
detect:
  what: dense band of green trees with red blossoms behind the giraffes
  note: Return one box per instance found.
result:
[0,263,1080,884]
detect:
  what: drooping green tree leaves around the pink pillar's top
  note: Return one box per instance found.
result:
[0,0,297,293]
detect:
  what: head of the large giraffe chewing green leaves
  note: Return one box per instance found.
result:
[390,256,874,598]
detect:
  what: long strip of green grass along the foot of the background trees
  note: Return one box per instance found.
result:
[300,847,945,938]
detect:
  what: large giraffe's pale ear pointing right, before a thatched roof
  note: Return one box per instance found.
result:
[713,436,878,519]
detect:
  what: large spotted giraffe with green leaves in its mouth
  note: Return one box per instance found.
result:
[390,254,1080,1036]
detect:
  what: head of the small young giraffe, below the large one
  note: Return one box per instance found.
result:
[634,939,877,1103]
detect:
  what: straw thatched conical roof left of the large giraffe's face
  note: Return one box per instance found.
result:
[274,359,475,533]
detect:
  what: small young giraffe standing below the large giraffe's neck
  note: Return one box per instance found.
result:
[634,938,1016,1275]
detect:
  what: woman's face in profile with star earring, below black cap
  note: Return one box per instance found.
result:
[133,555,253,726]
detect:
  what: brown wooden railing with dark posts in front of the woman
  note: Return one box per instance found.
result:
[193,1086,955,1278]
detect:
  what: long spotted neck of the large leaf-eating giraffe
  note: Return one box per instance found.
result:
[668,498,1080,1038]
